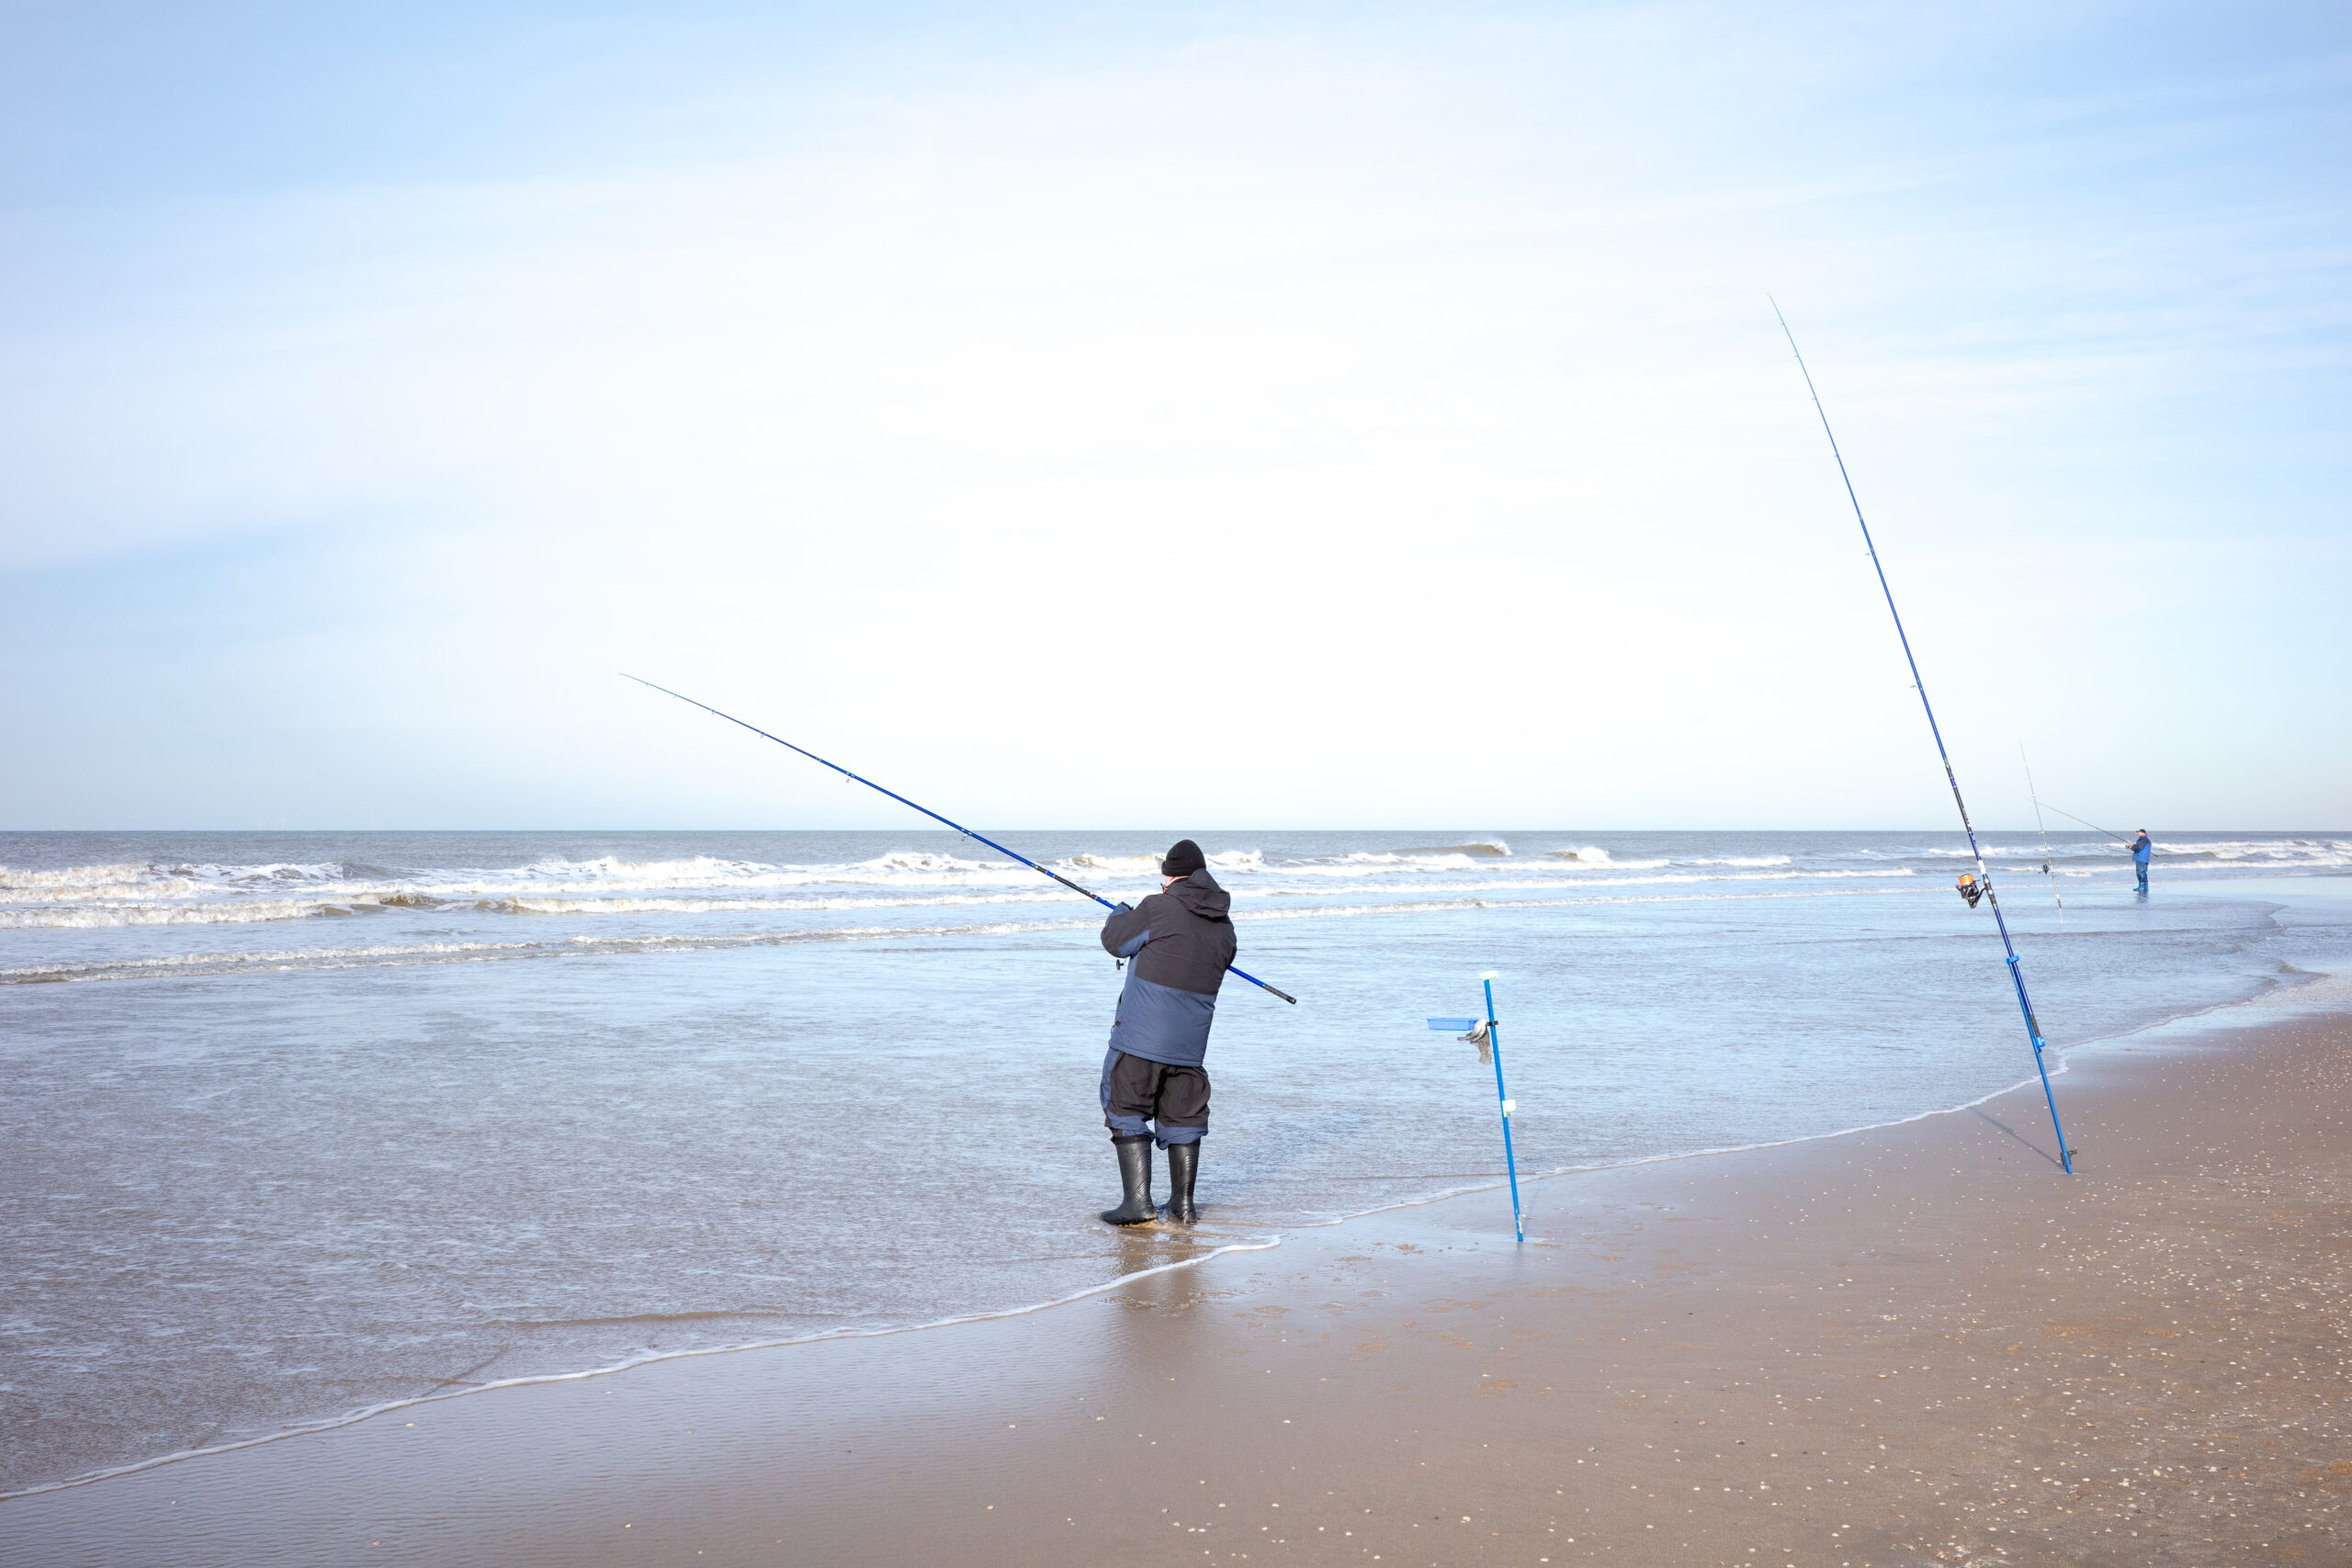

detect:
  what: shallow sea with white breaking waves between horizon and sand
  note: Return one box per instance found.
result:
[0,828,2352,1493]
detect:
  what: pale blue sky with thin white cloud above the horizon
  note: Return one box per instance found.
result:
[0,0,2352,829]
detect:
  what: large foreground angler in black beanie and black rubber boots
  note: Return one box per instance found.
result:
[1103,840,1235,1224]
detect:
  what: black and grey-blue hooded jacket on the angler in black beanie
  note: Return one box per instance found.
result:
[1103,870,1235,1067]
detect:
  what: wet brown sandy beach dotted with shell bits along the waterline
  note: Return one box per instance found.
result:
[0,1016,2352,1565]
